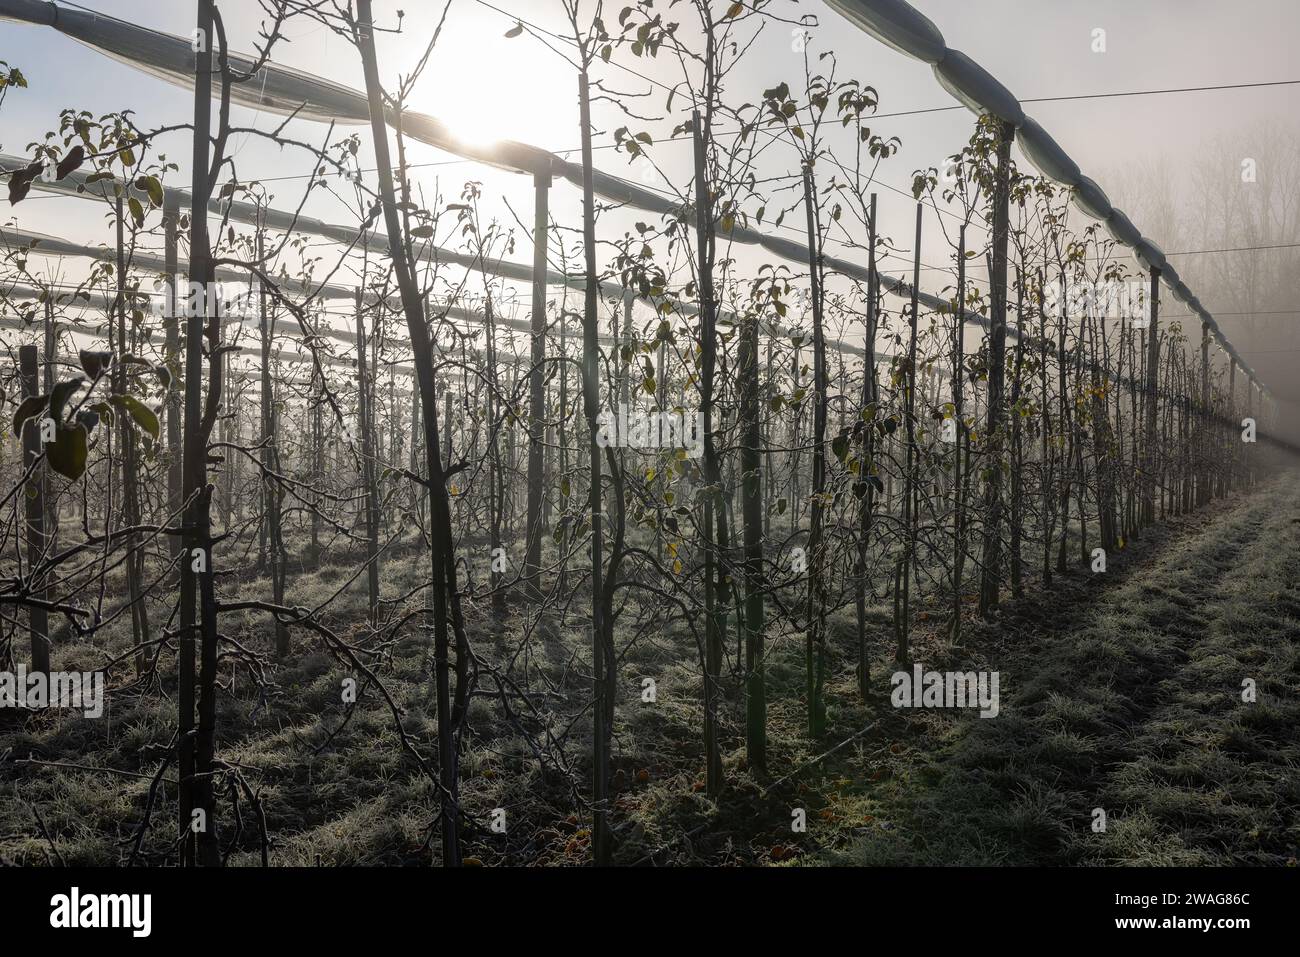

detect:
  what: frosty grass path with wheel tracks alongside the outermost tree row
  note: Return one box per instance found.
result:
[828,473,1300,866]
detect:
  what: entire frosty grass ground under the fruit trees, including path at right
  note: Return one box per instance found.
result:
[0,476,1300,866]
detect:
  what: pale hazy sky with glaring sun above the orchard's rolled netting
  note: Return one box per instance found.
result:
[0,0,1300,403]
